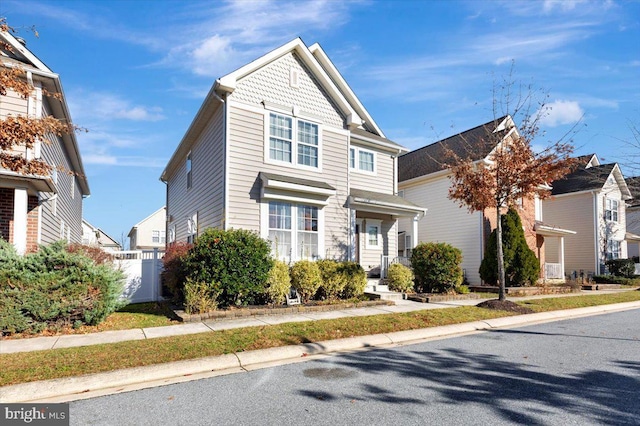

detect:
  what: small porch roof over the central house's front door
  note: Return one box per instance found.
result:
[347,189,427,216]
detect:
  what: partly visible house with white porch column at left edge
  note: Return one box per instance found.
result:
[0,31,89,253]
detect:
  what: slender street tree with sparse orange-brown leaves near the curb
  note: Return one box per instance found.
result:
[445,70,575,301]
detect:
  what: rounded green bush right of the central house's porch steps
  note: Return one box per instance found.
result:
[411,243,462,293]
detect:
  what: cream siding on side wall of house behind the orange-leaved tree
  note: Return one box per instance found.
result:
[398,176,488,284]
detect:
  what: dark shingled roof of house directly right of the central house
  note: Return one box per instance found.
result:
[398,116,507,182]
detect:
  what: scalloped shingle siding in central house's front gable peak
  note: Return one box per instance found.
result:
[230,53,344,128]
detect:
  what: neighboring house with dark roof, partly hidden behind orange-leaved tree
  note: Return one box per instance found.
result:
[398,116,572,285]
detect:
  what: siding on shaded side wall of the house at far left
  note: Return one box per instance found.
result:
[41,97,82,244]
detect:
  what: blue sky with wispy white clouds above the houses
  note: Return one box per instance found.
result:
[0,0,640,245]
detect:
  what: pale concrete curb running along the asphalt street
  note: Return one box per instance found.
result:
[0,302,640,403]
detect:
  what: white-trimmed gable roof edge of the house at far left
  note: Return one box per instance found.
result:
[0,31,91,196]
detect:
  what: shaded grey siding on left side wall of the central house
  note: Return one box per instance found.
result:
[167,104,225,241]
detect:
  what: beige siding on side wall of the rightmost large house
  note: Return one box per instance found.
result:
[542,192,596,274]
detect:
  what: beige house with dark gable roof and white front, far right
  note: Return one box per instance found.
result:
[543,154,631,276]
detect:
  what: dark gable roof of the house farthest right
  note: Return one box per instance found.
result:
[551,161,632,200]
